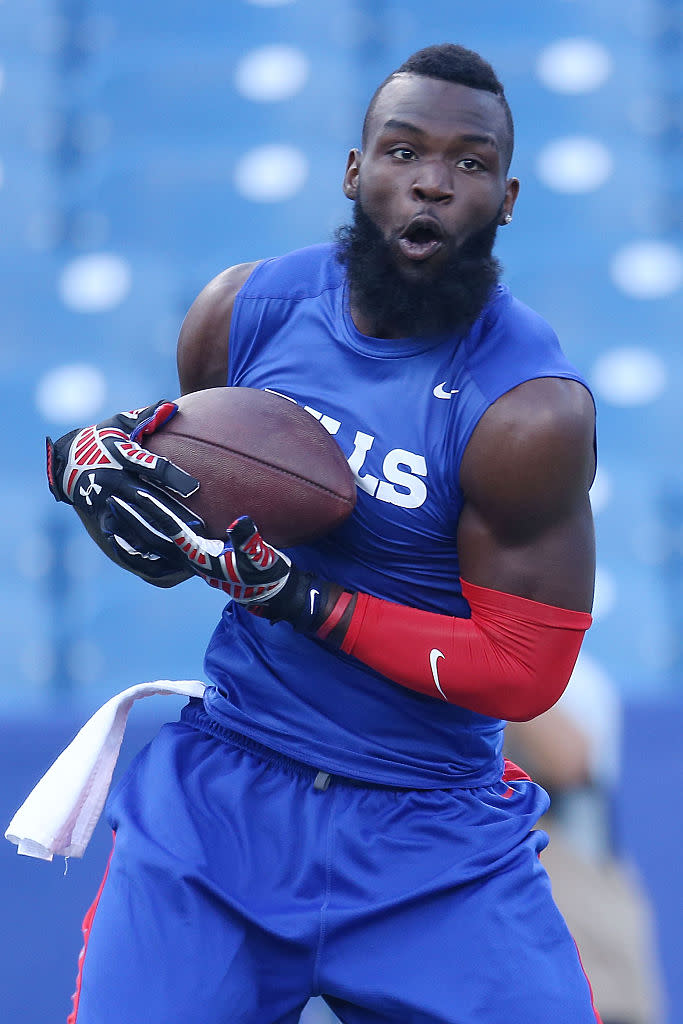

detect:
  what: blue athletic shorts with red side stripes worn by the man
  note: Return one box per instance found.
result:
[70,703,599,1024]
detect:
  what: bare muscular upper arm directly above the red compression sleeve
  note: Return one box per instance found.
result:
[458,379,595,611]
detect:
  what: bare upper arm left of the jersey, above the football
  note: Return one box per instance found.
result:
[177,263,256,394]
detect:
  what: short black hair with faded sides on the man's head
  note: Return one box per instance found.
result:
[362,43,515,170]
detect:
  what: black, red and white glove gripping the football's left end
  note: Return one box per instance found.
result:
[46,401,204,587]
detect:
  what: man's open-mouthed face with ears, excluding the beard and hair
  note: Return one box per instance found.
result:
[344,75,518,282]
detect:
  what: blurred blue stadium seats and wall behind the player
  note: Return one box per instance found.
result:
[0,0,683,1024]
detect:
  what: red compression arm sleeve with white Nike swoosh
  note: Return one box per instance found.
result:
[335,580,592,722]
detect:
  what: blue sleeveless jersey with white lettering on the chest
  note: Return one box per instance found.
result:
[205,245,584,788]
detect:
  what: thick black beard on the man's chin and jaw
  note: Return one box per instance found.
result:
[336,199,502,338]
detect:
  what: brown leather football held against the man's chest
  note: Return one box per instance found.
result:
[143,387,355,547]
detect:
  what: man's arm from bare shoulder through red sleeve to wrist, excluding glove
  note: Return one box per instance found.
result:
[301,378,595,721]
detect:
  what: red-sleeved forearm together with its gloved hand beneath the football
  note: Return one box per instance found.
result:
[129,512,591,721]
